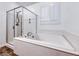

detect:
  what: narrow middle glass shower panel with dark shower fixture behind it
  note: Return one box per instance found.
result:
[15,8,22,37]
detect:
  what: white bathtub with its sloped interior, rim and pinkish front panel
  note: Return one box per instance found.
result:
[6,33,79,56]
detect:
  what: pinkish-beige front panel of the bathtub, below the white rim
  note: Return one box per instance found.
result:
[5,37,79,56]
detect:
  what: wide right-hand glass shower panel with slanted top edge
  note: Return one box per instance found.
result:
[22,9,36,38]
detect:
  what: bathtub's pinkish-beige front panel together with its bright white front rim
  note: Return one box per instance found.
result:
[13,37,79,56]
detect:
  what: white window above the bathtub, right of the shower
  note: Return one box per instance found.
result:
[40,3,60,25]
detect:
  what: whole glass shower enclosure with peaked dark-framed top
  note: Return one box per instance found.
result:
[6,6,37,42]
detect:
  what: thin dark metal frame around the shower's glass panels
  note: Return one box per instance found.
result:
[6,6,38,43]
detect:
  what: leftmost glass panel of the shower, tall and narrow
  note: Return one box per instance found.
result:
[6,10,15,42]
